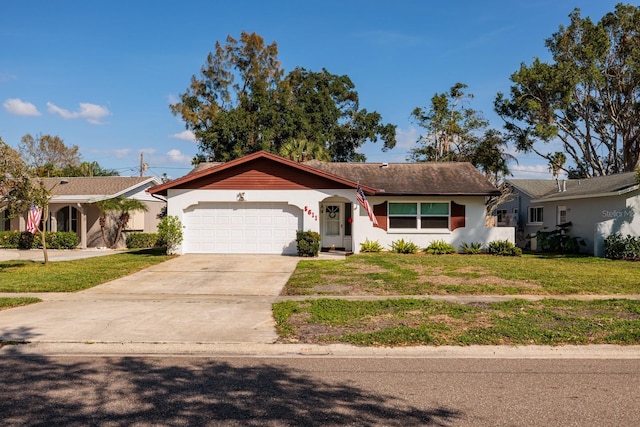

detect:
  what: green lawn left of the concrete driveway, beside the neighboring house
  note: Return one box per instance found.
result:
[0,249,171,292]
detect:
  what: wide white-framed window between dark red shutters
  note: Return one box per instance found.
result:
[389,202,449,230]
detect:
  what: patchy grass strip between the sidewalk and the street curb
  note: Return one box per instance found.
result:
[273,298,640,346]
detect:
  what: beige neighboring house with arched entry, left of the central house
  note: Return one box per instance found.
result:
[0,176,166,248]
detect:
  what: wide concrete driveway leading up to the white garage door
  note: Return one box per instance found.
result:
[0,255,299,343]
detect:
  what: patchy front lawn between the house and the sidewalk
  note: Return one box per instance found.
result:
[284,253,640,295]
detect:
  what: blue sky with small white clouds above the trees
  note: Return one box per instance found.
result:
[0,0,617,178]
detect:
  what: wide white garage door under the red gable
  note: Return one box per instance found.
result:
[184,203,302,254]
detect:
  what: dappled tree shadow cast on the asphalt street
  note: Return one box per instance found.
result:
[0,356,462,426]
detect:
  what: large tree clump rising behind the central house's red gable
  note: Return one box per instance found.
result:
[171,32,395,161]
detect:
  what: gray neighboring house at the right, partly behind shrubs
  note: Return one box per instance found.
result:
[500,172,640,256]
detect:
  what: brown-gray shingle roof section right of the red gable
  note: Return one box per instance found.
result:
[305,160,500,195]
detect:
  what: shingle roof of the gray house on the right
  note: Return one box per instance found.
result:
[509,172,637,201]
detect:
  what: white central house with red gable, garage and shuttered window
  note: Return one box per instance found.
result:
[149,151,514,254]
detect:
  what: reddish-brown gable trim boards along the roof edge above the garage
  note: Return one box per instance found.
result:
[147,151,377,196]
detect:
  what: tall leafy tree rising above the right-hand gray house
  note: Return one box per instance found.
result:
[495,4,640,177]
